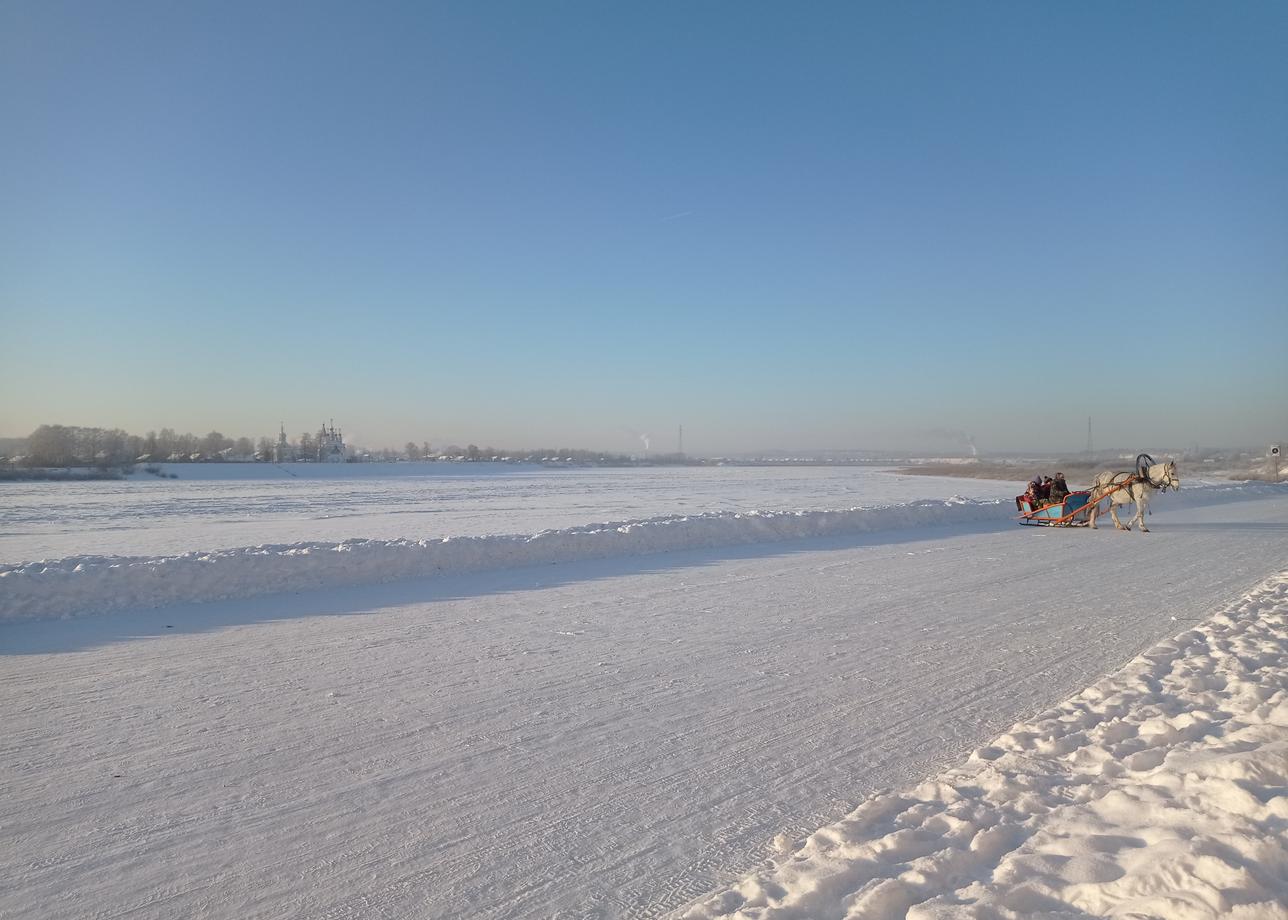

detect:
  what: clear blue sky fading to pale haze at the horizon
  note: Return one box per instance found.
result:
[0,0,1288,454]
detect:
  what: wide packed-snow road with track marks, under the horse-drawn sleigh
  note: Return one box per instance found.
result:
[0,497,1288,919]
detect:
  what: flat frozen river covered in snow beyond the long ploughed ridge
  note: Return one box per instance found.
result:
[0,463,1023,564]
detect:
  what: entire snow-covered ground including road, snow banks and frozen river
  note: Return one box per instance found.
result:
[0,468,1288,920]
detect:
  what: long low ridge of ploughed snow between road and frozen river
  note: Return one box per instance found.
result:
[0,497,1014,620]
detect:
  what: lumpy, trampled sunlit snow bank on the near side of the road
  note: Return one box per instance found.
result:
[683,572,1288,920]
